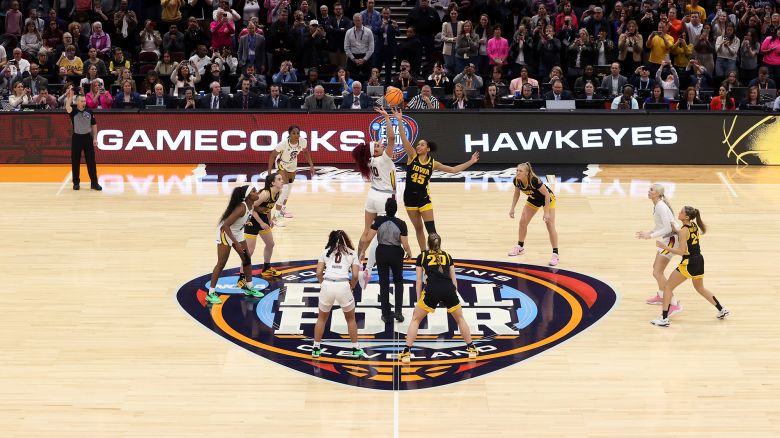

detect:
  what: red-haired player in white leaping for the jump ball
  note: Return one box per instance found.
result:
[352,107,395,289]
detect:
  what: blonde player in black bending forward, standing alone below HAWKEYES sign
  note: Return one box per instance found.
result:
[509,162,559,266]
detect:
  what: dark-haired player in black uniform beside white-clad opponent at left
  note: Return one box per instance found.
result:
[238,172,284,280]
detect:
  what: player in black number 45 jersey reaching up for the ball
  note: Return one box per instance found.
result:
[393,109,479,251]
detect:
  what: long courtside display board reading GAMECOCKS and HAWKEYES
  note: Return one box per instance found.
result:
[0,110,780,166]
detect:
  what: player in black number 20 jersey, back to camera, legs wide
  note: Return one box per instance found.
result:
[398,233,479,363]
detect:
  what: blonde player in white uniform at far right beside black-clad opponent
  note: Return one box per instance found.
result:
[636,184,682,316]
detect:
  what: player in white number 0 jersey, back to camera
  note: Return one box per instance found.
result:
[311,230,365,358]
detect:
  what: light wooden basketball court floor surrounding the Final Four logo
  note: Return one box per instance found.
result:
[0,164,780,437]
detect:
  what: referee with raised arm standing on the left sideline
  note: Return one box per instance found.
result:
[65,88,103,190]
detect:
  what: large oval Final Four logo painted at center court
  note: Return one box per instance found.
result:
[177,260,617,390]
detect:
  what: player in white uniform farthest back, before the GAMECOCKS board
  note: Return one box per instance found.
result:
[268,125,314,222]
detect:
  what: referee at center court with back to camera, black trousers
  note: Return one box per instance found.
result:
[368,198,412,323]
